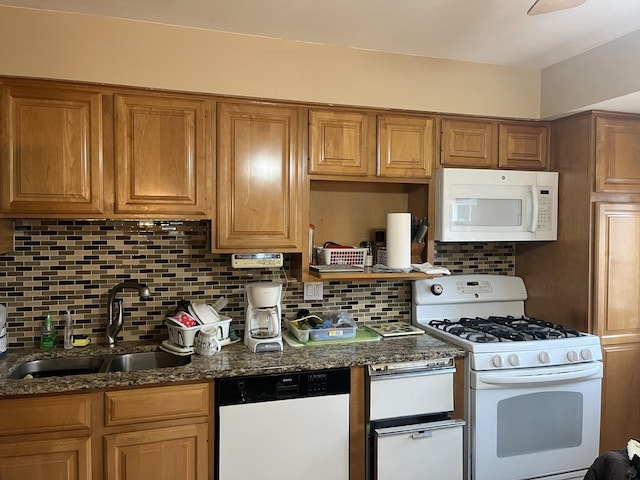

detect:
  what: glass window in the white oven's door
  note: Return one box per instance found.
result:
[497,391,584,458]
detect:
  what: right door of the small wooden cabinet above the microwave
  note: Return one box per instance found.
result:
[498,123,549,170]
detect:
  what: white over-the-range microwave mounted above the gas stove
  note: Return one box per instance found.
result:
[434,168,558,242]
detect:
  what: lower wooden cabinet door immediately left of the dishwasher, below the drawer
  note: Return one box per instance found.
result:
[104,423,206,480]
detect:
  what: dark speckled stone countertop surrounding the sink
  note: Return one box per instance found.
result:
[0,334,466,397]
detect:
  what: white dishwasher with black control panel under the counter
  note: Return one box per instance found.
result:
[216,368,351,480]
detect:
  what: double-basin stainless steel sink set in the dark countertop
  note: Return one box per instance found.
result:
[8,351,191,378]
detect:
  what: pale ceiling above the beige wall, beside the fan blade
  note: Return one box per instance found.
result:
[0,0,640,69]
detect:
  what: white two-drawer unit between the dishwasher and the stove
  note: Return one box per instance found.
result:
[368,358,465,480]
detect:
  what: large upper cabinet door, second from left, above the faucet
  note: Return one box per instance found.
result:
[115,95,211,217]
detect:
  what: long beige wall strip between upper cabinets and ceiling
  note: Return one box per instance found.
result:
[0,7,540,118]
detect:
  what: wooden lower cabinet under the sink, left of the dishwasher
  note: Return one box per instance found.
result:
[0,382,214,480]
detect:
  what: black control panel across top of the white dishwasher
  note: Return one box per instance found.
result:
[216,368,351,406]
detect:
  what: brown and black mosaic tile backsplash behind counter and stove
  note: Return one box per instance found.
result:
[0,220,515,347]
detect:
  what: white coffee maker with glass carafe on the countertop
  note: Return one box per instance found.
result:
[244,282,282,353]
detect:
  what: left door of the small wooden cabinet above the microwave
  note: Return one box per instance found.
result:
[440,118,498,168]
